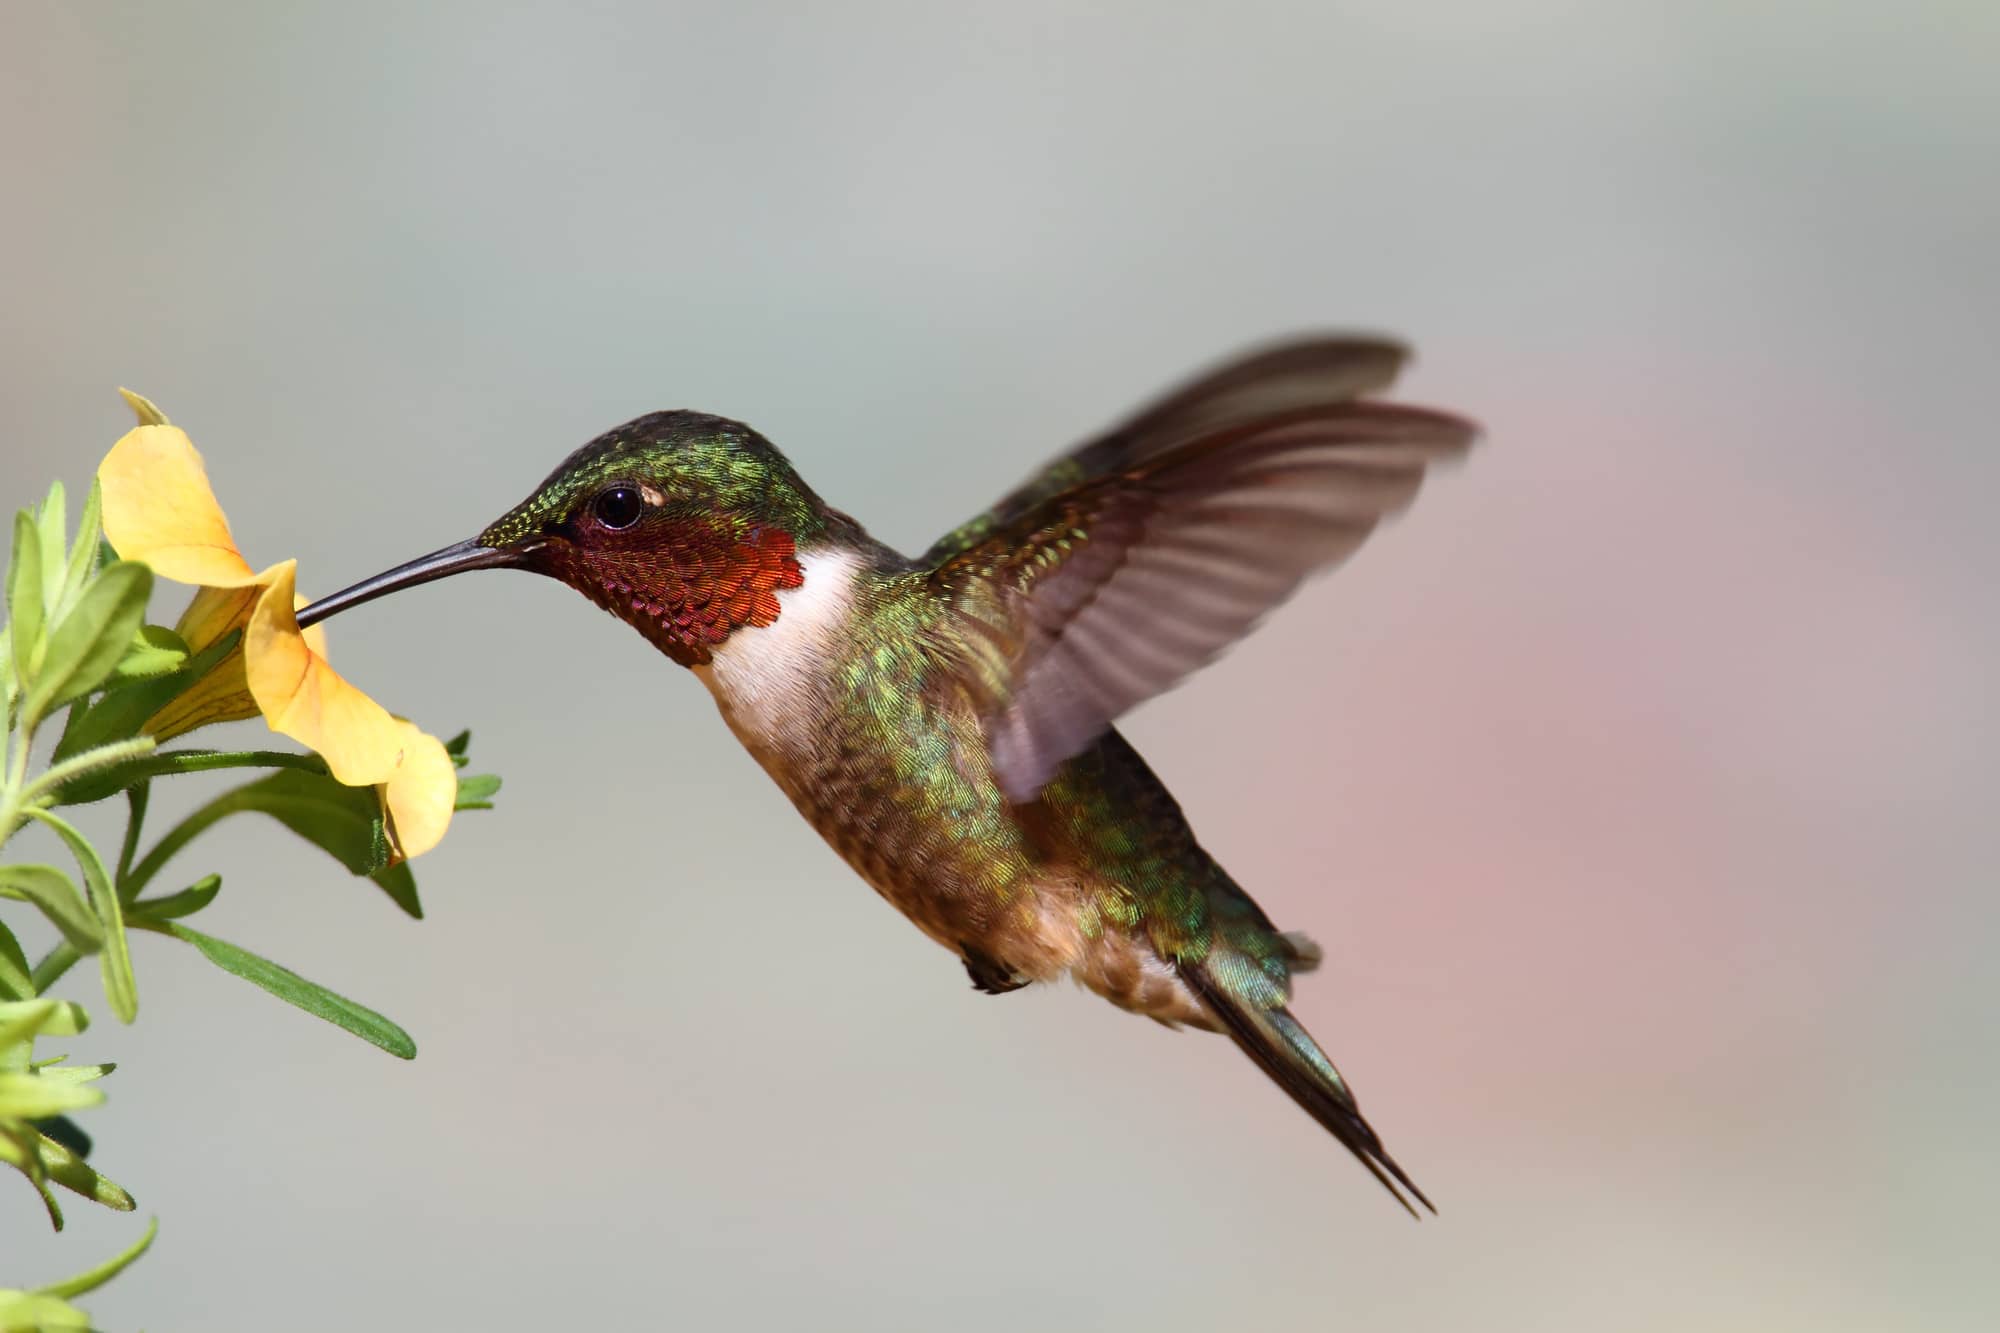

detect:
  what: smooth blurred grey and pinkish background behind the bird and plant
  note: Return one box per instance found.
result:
[0,0,2000,1333]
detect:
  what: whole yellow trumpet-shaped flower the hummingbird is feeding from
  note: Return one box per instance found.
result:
[98,394,458,859]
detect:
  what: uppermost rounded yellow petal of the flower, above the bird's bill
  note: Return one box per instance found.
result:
[98,426,258,588]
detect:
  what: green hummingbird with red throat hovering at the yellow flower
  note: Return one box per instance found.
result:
[298,336,1476,1217]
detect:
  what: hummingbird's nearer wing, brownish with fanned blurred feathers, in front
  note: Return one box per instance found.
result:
[930,396,1474,801]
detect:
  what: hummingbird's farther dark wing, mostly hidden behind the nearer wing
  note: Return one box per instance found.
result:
[924,336,1410,566]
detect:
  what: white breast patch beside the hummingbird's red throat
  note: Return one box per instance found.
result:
[694,550,860,757]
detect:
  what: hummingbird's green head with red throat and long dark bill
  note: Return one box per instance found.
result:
[298,412,838,667]
